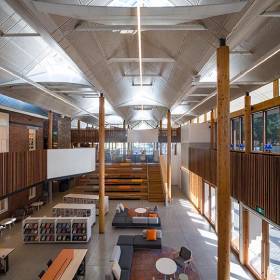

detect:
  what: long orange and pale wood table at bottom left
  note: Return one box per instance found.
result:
[42,249,87,280]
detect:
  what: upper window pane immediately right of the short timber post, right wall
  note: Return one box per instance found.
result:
[252,112,264,151]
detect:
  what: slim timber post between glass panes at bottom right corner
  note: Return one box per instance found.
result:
[262,220,269,280]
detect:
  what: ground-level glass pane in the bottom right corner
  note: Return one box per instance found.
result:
[268,225,280,280]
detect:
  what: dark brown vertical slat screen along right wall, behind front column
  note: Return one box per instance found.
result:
[189,148,280,225]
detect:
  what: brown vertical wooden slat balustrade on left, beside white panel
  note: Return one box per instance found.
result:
[0,150,47,198]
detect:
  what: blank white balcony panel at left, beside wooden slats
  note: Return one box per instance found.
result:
[47,148,96,179]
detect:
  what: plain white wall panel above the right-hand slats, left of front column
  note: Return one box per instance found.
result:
[181,123,210,143]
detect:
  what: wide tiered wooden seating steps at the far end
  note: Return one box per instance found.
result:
[76,163,148,199]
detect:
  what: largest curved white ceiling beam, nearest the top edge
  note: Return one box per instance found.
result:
[32,0,248,26]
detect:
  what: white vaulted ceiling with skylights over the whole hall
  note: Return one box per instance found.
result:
[0,0,280,126]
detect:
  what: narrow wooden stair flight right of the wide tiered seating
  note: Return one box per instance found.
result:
[147,163,164,202]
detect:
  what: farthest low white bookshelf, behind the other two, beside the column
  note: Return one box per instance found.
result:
[63,193,109,215]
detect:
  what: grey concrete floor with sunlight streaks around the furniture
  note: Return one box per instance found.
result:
[0,189,253,280]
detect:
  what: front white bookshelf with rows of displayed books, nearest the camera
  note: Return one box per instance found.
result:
[22,217,91,244]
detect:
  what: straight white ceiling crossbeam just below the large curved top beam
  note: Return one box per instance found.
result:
[74,21,207,33]
